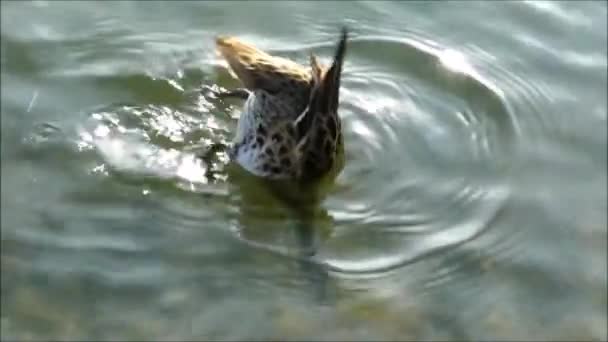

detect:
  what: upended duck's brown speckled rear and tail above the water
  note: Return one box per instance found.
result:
[216,30,347,181]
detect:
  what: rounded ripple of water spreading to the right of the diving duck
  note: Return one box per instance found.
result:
[218,37,517,276]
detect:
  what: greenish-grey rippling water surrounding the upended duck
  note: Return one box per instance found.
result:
[0,1,608,340]
